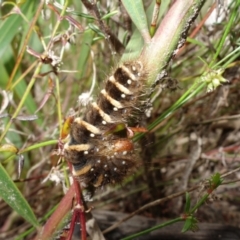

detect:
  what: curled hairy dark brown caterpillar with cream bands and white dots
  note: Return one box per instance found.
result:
[64,60,148,188]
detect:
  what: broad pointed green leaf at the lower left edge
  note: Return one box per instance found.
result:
[0,164,39,227]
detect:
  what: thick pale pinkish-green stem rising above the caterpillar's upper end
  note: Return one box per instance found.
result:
[141,0,205,86]
